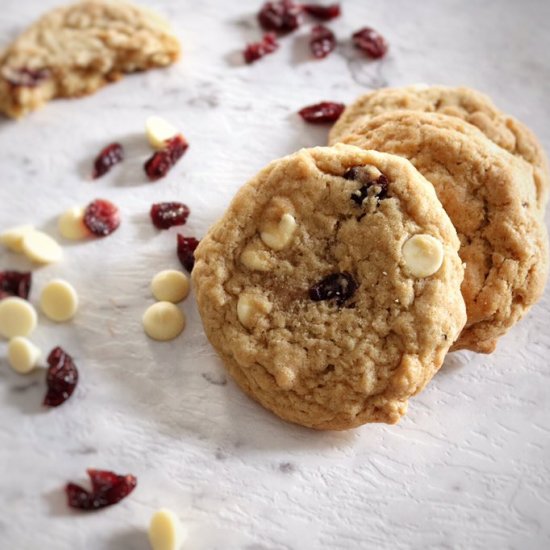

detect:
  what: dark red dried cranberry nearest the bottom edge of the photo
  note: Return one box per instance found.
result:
[65,468,137,510]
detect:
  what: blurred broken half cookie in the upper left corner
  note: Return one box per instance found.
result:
[0,0,180,118]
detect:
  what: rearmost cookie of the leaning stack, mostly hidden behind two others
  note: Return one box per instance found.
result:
[329,85,550,212]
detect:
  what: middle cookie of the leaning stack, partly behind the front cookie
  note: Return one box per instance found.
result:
[338,111,548,353]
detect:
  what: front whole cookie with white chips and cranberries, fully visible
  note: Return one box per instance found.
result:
[192,145,465,430]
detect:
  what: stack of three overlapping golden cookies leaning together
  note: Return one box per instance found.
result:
[193,86,550,429]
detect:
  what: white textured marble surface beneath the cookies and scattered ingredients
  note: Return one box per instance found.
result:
[0,0,550,550]
